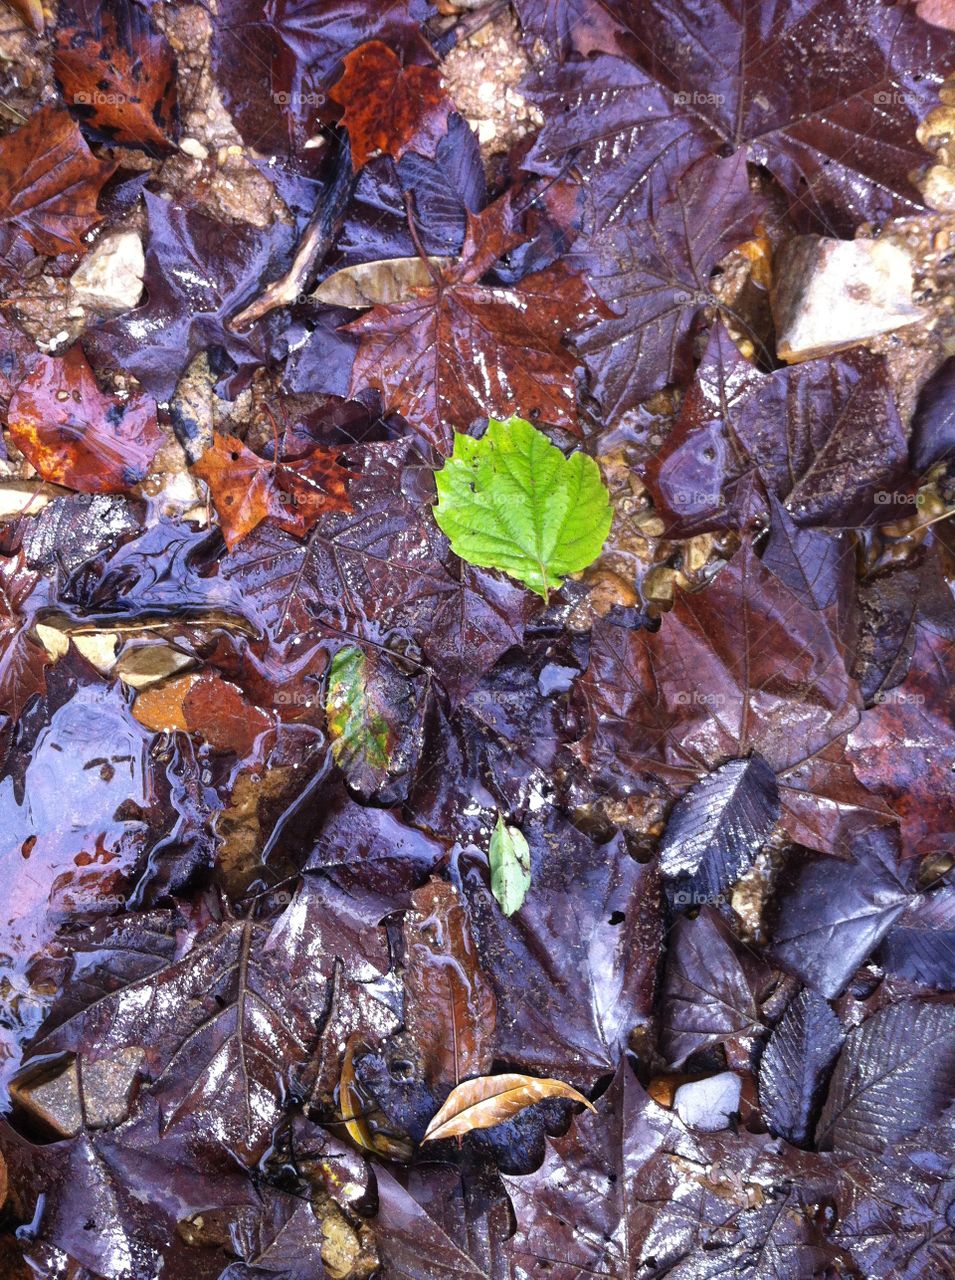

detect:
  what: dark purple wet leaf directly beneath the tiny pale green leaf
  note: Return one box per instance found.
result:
[463,814,663,1087]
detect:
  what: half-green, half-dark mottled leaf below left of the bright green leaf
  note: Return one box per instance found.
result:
[325,645,422,804]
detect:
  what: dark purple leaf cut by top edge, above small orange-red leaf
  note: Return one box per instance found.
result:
[213,0,431,152]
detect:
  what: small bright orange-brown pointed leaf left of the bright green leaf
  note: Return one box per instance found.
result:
[193,431,352,547]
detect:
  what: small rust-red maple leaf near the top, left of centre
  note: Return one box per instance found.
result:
[329,40,454,172]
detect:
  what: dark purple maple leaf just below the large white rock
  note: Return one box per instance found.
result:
[646,329,909,538]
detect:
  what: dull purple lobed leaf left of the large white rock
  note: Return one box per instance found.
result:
[572,154,764,419]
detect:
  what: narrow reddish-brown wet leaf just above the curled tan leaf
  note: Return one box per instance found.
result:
[405,877,497,1087]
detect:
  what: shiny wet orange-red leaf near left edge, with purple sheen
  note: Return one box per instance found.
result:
[8,346,165,493]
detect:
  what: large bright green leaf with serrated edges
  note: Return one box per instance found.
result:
[434,417,611,600]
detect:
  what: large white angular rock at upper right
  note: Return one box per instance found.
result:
[772,236,926,364]
